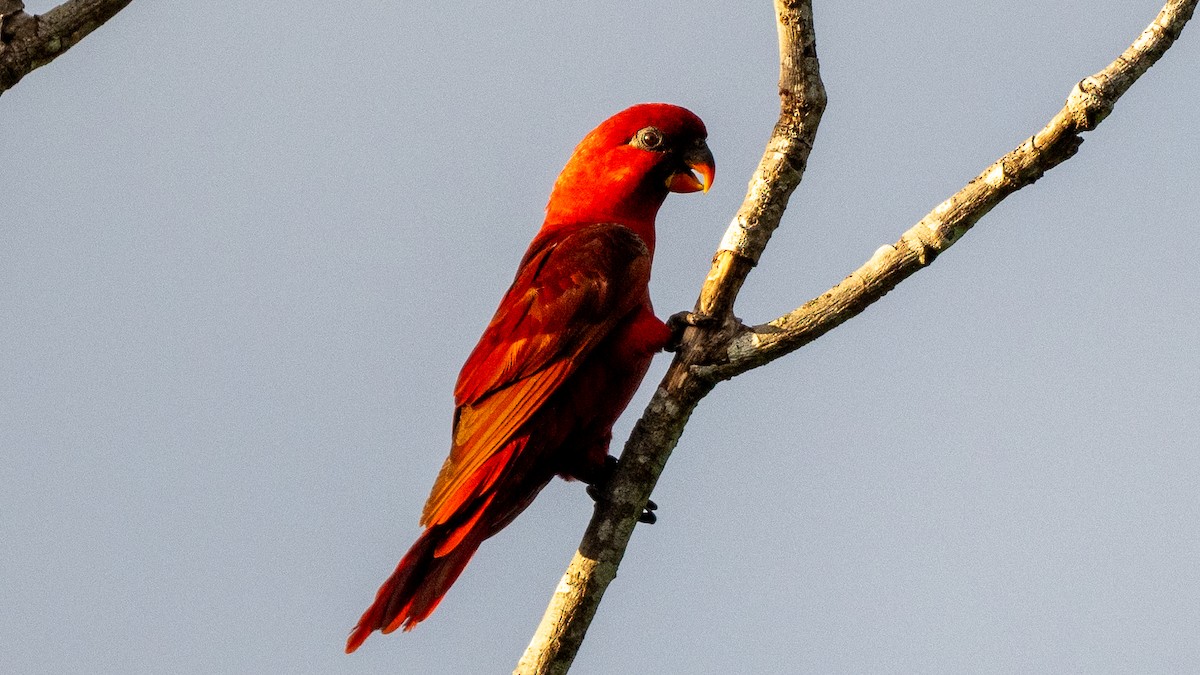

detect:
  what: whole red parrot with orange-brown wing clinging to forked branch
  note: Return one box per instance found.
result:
[346,103,715,653]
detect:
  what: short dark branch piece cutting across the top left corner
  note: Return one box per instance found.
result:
[0,0,131,95]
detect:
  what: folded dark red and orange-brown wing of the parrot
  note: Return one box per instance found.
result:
[421,223,650,526]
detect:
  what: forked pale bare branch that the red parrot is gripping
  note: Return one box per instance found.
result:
[514,0,1198,675]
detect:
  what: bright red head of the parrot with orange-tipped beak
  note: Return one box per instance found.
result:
[546,103,716,235]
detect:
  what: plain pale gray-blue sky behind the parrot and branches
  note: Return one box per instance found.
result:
[0,0,1200,674]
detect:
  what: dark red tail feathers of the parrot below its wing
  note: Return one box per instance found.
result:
[346,526,484,653]
